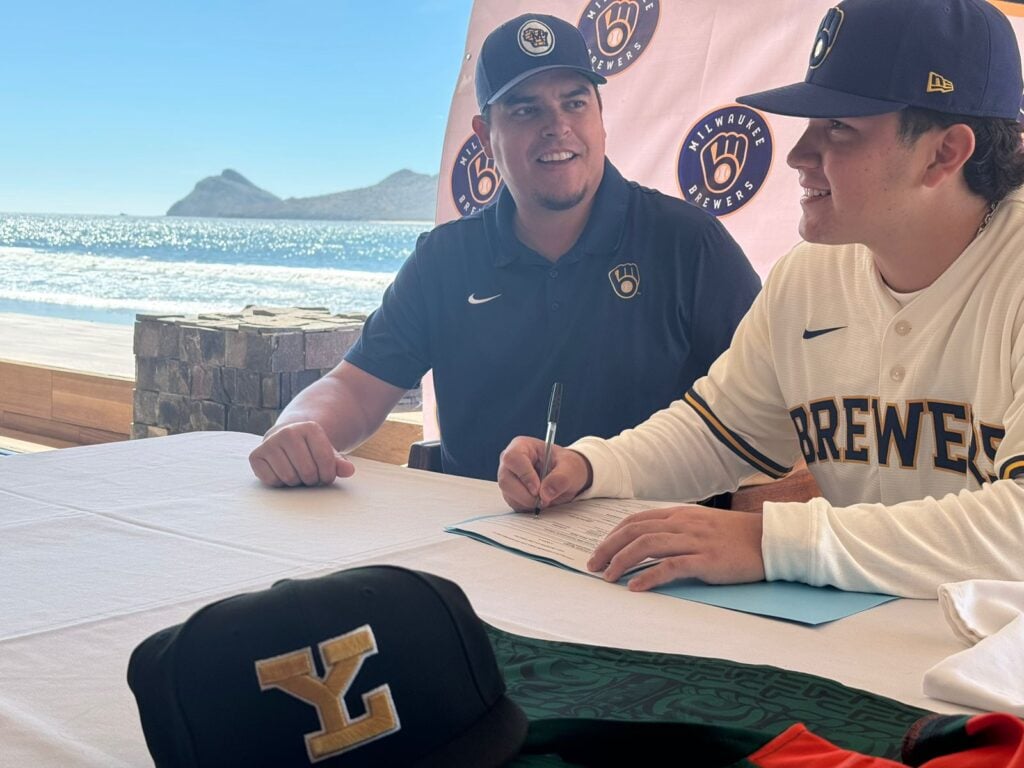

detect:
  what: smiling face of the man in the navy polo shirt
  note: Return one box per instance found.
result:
[473,70,604,215]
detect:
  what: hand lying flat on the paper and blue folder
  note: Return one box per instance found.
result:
[587,505,765,592]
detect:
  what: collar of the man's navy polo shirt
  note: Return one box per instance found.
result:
[495,158,630,266]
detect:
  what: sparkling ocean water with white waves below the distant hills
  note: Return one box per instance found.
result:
[0,213,432,324]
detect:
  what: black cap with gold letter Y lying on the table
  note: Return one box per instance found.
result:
[128,565,527,768]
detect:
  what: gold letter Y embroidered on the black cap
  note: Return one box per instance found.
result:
[256,625,401,762]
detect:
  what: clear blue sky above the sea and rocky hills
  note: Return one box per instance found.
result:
[0,0,472,215]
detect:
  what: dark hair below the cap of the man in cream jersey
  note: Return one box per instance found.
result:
[899,106,1024,203]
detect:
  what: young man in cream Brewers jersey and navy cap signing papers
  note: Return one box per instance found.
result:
[499,0,1024,598]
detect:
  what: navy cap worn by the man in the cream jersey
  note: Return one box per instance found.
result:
[736,0,1024,120]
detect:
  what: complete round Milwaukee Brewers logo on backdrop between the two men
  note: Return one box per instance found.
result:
[678,104,772,216]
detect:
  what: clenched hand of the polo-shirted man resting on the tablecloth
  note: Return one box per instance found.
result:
[249,421,355,487]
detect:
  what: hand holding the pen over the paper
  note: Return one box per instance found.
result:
[498,437,591,512]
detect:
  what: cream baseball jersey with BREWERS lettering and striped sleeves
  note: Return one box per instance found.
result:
[573,190,1024,597]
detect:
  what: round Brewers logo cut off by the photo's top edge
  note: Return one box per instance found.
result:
[577,0,659,77]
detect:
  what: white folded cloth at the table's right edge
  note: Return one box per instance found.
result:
[924,580,1024,717]
